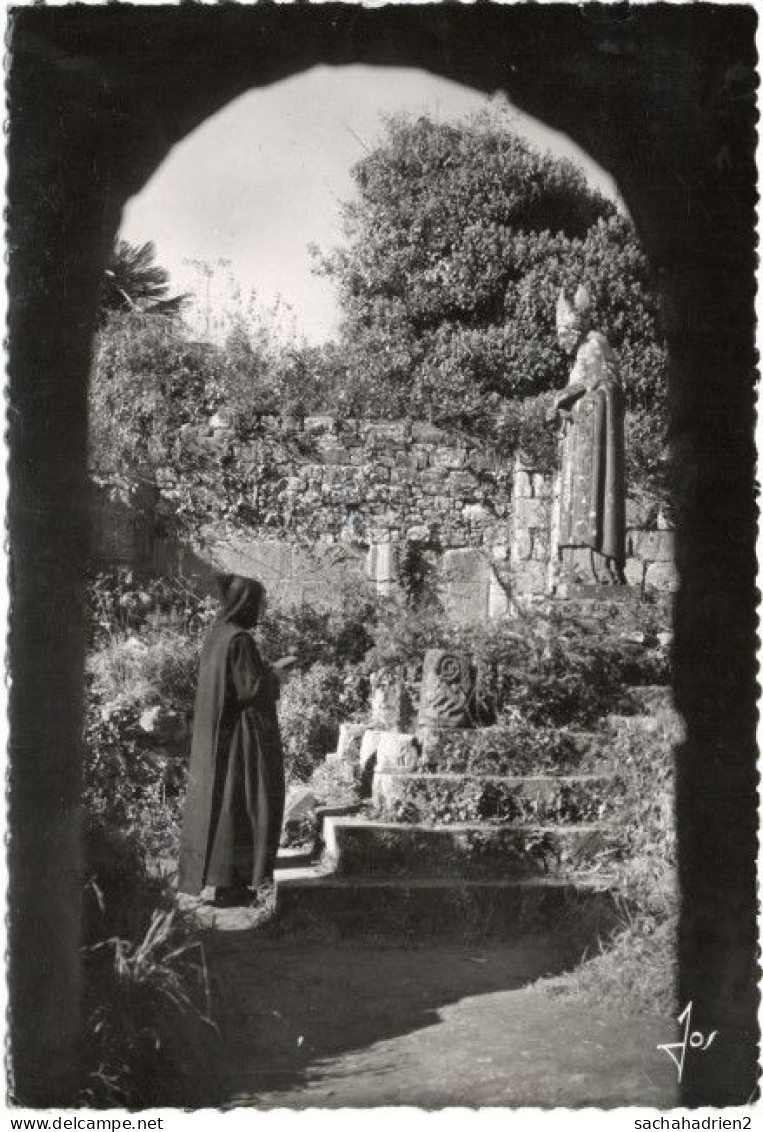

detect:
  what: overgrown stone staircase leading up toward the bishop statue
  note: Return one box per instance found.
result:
[271,586,670,955]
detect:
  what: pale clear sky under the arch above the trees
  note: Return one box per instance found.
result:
[120,66,617,343]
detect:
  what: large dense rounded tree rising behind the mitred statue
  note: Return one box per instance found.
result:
[315,112,666,491]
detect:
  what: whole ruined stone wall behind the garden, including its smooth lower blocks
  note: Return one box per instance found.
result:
[93,417,512,619]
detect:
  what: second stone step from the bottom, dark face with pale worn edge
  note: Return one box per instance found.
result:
[323,817,616,880]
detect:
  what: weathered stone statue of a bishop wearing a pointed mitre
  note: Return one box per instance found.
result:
[552,286,625,585]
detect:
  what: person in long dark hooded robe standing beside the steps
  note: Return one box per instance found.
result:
[178,575,284,903]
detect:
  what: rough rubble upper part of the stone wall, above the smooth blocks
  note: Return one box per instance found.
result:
[220,417,511,549]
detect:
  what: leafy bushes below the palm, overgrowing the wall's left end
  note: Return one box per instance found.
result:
[89,310,348,534]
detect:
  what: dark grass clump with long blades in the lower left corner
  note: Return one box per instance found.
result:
[77,820,215,1108]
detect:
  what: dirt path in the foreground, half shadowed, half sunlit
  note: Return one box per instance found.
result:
[193,931,677,1108]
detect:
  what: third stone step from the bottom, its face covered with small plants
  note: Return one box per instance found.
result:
[374,767,612,825]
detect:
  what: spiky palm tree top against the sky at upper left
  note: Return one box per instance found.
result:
[101,240,188,315]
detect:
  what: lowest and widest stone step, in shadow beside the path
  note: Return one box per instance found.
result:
[269,869,618,941]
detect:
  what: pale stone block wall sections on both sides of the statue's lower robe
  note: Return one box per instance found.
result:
[509,461,678,599]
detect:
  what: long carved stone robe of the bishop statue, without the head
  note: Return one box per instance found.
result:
[558,332,625,567]
